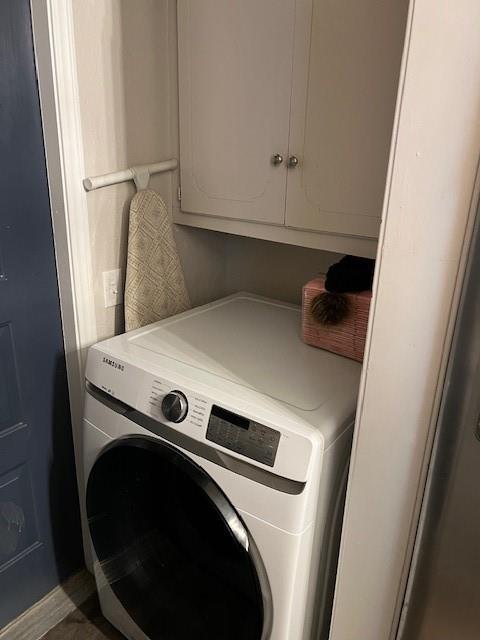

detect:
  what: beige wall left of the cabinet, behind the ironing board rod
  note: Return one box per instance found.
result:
[73,0,172,338]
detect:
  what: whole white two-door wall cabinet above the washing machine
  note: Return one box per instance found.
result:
[178,0,408,253]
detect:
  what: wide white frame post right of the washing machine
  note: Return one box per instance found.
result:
[330,0,480,640]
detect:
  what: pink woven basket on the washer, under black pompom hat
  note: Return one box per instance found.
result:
[303,277,372,362]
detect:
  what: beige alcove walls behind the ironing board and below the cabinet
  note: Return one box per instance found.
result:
[73,0,335,339]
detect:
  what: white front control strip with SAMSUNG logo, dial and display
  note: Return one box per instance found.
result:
[86,348,316,482]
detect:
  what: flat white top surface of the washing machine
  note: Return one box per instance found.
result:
[126,294,361,411]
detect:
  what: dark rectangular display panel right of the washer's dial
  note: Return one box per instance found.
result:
[207,405,280,467]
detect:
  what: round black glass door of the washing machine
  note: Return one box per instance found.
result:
[87,437,271,640]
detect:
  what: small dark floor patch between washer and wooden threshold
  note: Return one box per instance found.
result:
[42,596,125,640]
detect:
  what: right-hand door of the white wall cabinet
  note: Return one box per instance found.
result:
[286,0,408,237]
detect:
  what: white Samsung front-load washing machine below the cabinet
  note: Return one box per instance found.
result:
[83,294,360,640]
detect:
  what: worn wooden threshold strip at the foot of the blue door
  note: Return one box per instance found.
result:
[0,570,95,640]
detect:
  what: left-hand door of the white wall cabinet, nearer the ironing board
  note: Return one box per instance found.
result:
[178,0,295,224]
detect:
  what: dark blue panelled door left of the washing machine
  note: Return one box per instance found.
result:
[0,0,81,628]
